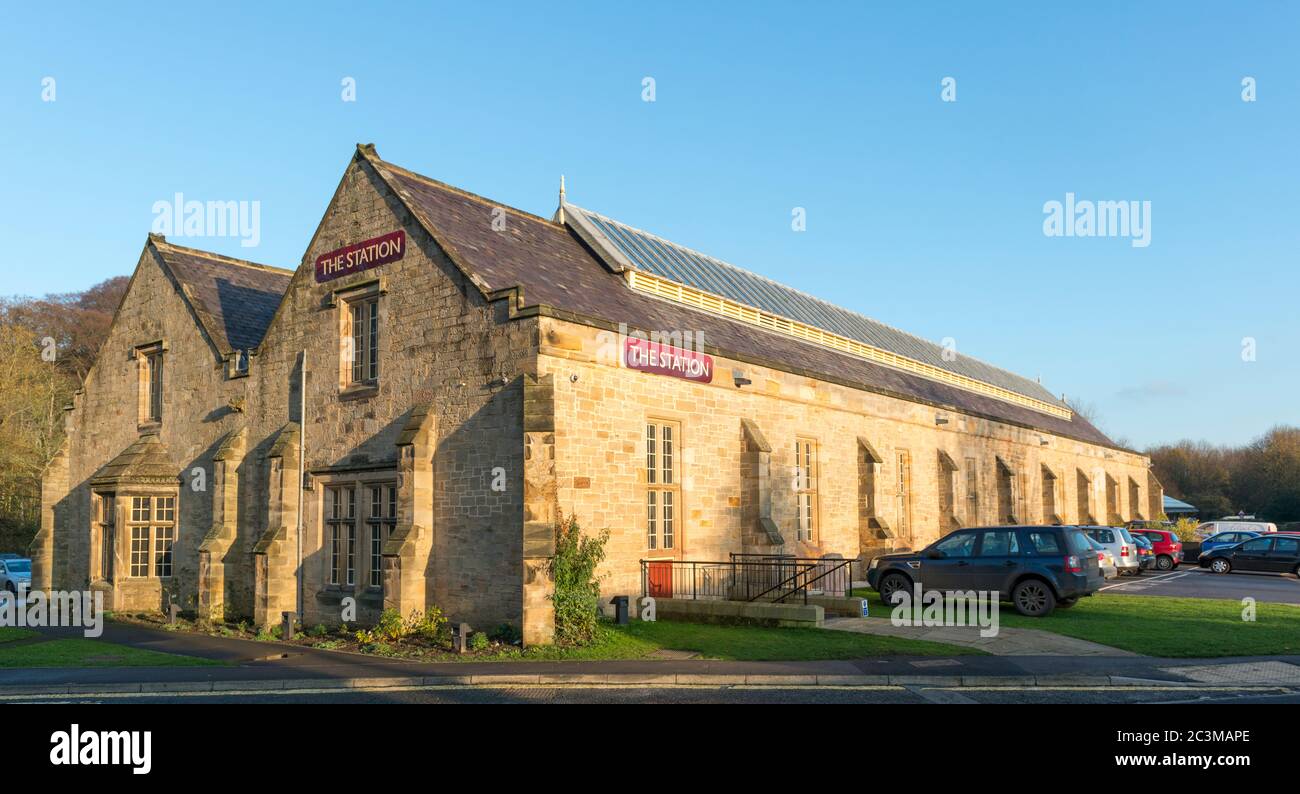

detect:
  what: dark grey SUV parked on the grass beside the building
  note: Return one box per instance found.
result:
[867,526,1104,617]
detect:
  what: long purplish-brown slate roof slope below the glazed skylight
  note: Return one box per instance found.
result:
[358,146,1115,447]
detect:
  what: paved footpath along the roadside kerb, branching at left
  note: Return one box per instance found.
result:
[0,624,1300,702]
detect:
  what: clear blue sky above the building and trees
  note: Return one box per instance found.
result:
[0,1,1300,447]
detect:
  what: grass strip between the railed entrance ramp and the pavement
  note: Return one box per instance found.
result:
[499,621,982,661]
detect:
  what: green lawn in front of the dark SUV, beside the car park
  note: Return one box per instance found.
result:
[854,590,1300,656]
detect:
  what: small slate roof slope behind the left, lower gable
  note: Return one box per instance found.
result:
[150,234,294,356]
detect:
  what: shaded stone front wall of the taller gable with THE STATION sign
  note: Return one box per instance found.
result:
[239,157,537,629]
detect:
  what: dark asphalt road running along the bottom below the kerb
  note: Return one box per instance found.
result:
[12,686,1300,706]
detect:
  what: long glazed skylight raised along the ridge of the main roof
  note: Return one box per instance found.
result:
[564,204,1065,407]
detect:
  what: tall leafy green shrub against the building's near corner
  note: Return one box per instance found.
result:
[547,516,610,645]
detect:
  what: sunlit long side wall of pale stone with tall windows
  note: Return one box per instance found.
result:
[538,313,1148,594]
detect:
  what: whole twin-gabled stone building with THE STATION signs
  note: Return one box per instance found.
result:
[33,146,1162,642]
